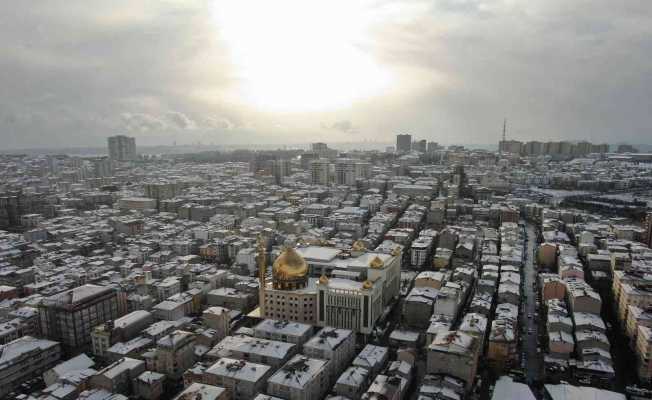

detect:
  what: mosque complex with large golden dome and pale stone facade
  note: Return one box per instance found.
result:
[258,244,401,334]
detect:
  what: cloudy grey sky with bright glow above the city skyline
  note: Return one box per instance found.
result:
[0,0,652,149]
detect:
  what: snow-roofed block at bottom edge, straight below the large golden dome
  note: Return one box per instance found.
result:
[267,355,330,400]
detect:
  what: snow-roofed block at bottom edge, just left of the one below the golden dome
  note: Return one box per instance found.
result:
[204,358,273,400]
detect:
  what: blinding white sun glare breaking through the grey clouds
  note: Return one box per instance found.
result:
[212,0,391,112]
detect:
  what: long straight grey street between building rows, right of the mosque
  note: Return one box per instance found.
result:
[520,223,543,384]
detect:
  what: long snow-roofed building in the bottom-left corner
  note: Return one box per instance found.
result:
[0,336,61,398]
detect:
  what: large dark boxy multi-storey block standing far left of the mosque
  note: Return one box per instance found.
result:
[39,285,120,353]
